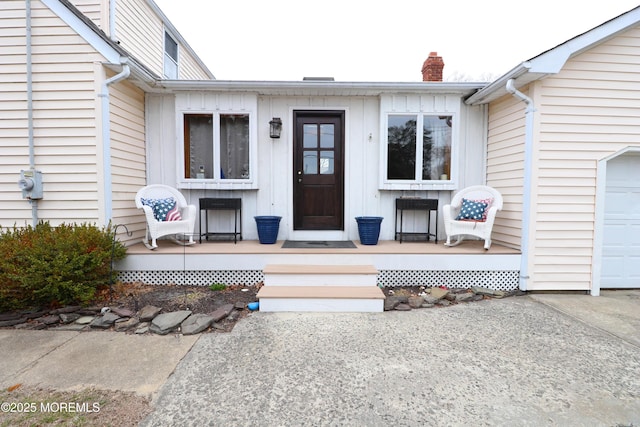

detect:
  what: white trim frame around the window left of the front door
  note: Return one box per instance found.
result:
[176,110,258,190]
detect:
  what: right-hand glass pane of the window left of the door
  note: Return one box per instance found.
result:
[220,114,249,179]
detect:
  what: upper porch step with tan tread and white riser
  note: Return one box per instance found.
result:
[263,264,378,286]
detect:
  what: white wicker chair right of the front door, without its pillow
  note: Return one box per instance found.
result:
[442,185,502,249]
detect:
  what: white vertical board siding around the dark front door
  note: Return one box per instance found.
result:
[147,91,484,240]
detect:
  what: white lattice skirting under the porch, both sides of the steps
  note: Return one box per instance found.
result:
[118,270,519,291]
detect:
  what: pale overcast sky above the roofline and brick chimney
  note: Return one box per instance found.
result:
[154,0,638,82]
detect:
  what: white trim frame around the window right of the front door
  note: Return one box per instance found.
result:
[379,110,460,190]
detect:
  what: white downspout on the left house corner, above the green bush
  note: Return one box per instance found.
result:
[98,58,131,224]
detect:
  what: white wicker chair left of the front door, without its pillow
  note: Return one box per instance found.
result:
[136,184,196,249]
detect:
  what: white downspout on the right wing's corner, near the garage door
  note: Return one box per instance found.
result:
[506,79,536,291]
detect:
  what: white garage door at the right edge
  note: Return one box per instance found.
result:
[600,154,640,288]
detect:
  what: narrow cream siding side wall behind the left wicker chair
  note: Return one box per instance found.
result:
[109,76,146,244]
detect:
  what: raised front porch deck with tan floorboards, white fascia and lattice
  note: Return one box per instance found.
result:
[115,240,521,290]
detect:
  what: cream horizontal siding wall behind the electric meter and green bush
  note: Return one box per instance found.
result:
[0,1,103,227]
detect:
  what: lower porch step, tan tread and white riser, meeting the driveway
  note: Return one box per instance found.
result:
[258,285,385,313]
